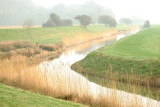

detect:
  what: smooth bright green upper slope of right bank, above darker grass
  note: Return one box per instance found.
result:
[97,26,160,60]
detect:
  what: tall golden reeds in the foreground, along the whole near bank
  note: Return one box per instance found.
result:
[0,56,159,107]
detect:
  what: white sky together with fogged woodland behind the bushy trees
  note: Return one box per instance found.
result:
[0,0,160,26]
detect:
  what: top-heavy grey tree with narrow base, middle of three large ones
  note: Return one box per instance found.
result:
[75,15,92,28]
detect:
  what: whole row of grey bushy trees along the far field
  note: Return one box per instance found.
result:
[42,13,150,28]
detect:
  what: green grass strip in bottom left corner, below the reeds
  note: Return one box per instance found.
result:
[0,83,85,107]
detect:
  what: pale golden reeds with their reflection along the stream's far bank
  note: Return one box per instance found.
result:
[63,30,120,51]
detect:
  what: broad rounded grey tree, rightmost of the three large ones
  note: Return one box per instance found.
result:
[98,15,117,27]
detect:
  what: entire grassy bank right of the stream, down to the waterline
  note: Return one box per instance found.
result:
[72,26,160,99]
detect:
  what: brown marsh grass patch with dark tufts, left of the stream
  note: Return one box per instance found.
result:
[0,41,63,62]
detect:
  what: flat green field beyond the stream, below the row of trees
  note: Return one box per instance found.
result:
[0,25,130,44]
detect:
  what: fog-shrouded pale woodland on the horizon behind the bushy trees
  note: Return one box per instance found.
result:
[0,0,145,26]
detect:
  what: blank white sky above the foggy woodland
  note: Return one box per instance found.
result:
[32,0,160,24]
